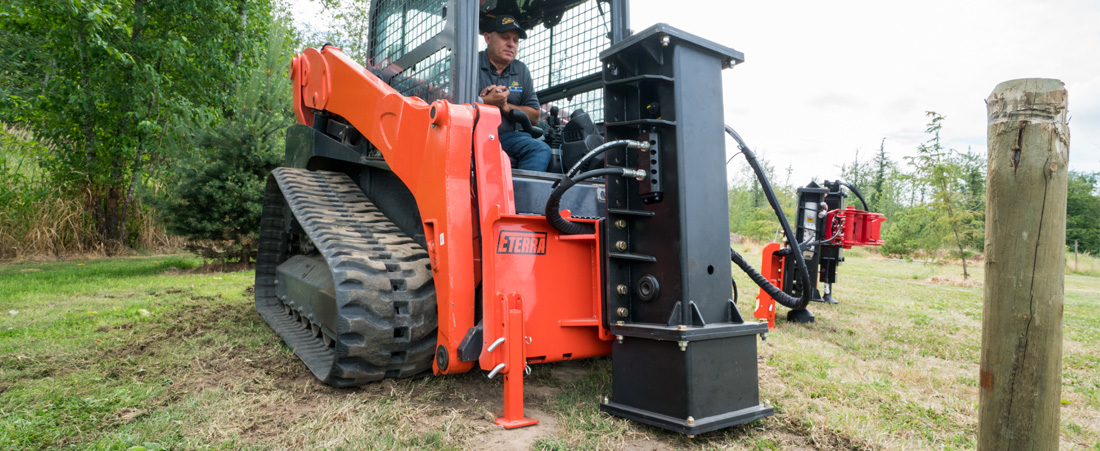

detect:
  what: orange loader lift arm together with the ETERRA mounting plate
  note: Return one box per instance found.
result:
[290,46,612,385]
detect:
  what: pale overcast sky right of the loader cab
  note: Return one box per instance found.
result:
[292,0,1100,185]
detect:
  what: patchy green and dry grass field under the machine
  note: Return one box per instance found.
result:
[0,252,1100,450]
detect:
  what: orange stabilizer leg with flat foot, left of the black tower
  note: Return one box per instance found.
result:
[495,296,539,429]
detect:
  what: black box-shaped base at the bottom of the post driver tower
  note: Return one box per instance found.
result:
[600,322,774,436]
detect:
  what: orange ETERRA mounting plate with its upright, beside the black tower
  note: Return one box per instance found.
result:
[474,106,611,374]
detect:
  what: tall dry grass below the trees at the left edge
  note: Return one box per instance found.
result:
[0,124,182,260]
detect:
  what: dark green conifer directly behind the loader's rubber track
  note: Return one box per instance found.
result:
[156,24,293,263]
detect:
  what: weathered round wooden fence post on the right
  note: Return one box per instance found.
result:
[978,78,1069,451]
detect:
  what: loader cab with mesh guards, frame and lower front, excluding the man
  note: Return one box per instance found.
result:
[366,0,629,217]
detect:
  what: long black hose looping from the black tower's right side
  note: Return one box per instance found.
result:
[726,125,813,310]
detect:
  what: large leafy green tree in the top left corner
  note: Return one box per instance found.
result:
[0,0,272,248]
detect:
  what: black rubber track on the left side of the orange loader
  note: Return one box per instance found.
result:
[256,167,438,386]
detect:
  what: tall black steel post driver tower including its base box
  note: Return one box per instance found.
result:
[600,24,773,435]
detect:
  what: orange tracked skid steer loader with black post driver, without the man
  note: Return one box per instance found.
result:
[256,0,875,435]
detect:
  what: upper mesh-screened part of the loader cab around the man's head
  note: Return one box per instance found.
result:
[367,0,629,110]
